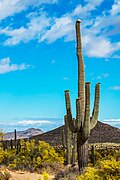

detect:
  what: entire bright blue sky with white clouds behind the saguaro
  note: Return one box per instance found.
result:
[0,0,120,131]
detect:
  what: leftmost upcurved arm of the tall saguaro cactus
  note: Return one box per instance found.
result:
[65,90,77,133]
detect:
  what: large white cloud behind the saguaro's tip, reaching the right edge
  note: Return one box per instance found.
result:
[40,0,120,58]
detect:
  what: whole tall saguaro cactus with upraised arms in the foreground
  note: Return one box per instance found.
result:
[65,20,100,171]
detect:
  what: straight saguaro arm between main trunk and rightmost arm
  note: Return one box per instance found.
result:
[83,82,90,141]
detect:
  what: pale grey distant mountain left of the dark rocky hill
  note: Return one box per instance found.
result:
[4,128,43,140]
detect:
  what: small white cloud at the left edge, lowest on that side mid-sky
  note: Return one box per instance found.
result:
[0,57,30,74]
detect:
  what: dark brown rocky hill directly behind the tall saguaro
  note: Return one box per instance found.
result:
[31,121,120,145]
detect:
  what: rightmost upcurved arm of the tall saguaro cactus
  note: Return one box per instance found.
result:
[90,83,100,129]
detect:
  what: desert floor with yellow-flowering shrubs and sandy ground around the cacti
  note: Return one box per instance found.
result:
[0,140,120,180]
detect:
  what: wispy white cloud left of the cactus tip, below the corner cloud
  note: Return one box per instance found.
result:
[0,13,50,46]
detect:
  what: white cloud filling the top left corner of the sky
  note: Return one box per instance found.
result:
[0,0,57,20]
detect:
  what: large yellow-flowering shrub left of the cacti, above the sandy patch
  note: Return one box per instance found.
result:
[9,140,64,171]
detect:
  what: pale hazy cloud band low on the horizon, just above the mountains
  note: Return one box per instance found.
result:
[0,118,120,133]
